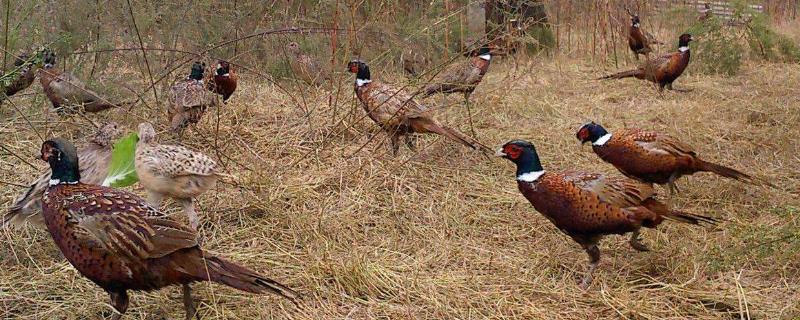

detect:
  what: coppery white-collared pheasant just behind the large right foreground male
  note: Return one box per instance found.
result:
[576,122,756,193]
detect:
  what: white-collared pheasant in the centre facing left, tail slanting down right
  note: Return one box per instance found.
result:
[347,60,487,155]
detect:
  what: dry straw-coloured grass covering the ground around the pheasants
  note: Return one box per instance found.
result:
[0,52,800,319]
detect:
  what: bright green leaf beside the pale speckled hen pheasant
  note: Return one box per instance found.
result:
[103,132,139,188]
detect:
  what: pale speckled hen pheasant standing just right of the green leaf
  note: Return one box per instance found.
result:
[135,122,222,230]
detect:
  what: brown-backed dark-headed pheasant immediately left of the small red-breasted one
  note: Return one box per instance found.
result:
[167,62,217,137]
